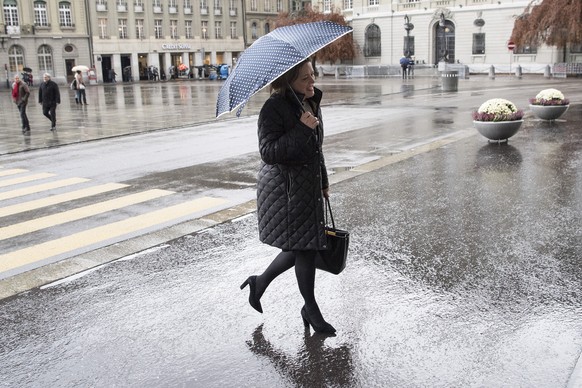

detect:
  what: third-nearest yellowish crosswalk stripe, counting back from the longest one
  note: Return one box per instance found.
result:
[0,183,128,217]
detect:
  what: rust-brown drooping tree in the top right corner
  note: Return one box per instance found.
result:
[511,0,582,61]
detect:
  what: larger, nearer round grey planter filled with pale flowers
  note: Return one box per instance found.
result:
[473,98,523,142]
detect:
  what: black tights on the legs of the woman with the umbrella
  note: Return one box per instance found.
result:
[255,251,317,309]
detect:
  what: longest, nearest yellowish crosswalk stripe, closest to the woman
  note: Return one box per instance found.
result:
[0,197,227,272]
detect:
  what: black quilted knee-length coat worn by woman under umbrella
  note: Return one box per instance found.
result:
[257,89,329,250]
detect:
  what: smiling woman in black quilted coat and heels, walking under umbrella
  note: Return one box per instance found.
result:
[241,60,335,334]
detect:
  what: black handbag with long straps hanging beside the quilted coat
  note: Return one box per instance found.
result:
[315,198,350,275]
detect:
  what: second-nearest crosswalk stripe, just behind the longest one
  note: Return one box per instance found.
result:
[0,189,174,240]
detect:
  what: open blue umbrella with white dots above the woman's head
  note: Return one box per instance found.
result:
[216,21,352,117]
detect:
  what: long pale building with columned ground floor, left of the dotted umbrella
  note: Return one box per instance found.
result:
[88,0,250,82]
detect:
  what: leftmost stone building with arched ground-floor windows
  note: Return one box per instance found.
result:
[0,0,91,83]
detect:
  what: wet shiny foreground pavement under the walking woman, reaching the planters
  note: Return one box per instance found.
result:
[0,76,582,387]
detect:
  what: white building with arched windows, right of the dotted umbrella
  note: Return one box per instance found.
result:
[342,0,582,72]
